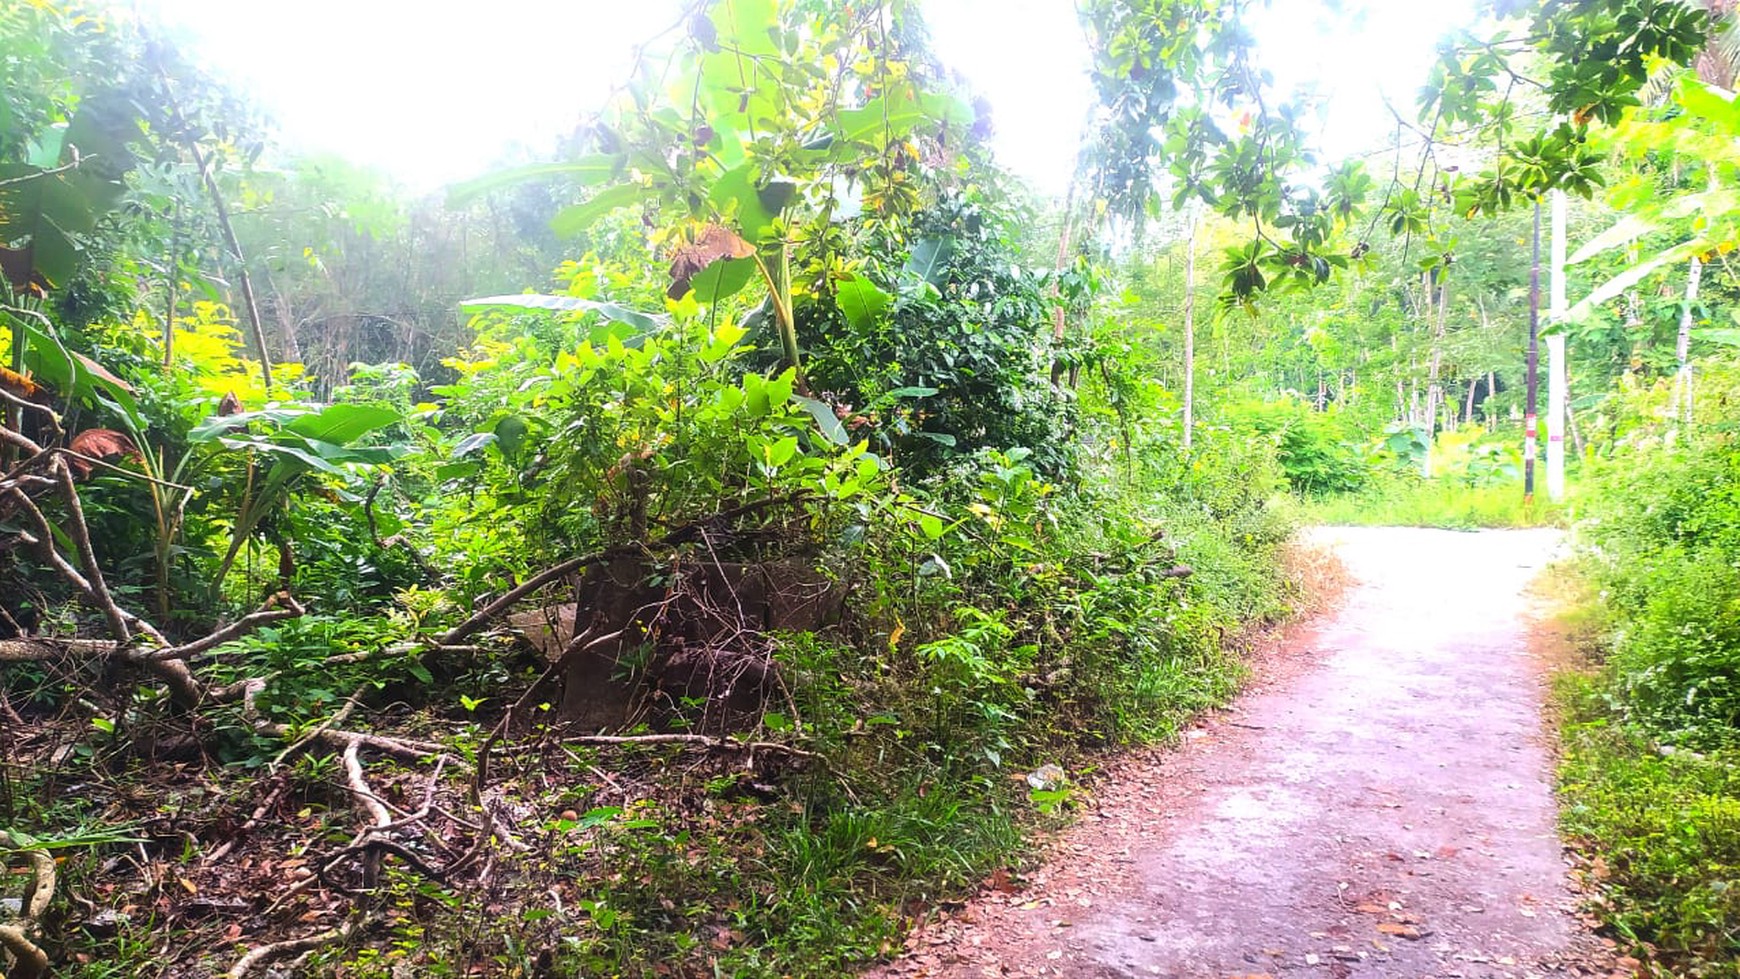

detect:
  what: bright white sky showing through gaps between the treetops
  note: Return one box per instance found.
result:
[137,0,1474,195]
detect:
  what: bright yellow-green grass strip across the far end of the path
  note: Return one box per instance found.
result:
[1302,476,1569,530]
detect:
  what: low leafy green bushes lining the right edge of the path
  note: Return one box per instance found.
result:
[1561,362,1740,976]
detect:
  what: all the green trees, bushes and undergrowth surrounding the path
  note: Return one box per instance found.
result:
[0,0,1740,979]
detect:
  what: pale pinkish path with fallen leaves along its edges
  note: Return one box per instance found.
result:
[879,529,1610,979]
